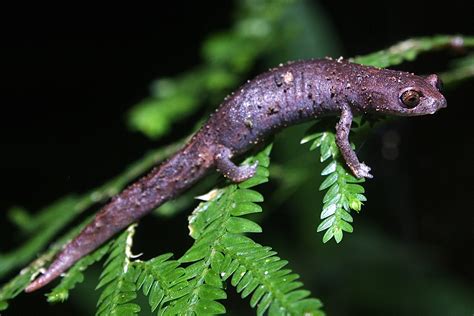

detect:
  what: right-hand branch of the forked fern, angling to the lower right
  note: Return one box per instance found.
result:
[217,234,324,315]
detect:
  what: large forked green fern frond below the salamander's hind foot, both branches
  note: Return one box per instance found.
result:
[152,146,322,315]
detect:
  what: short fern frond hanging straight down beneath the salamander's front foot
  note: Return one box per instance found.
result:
[301,127,367,243]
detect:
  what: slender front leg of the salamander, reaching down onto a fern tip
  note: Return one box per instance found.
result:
[336,106,372,178]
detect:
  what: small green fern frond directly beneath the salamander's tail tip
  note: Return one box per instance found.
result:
[46,243,110,303]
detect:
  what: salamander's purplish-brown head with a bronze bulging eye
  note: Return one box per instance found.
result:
[356,69,446,116]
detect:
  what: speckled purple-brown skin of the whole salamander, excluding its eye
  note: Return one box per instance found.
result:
[26,59,446,292]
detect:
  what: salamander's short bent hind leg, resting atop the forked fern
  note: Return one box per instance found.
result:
[215,147,258,183]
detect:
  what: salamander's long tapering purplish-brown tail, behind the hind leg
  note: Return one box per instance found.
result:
[25,139,213,292]
